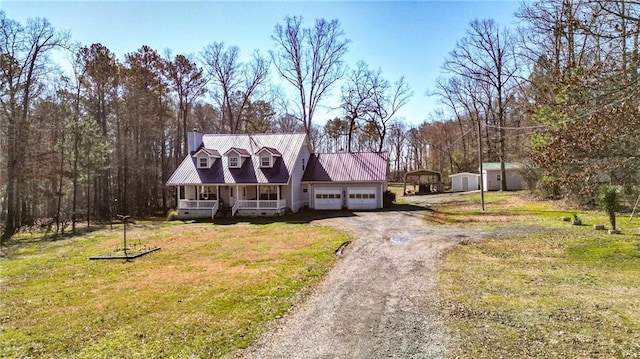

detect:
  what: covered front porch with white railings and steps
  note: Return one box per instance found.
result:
[177,185,287,219]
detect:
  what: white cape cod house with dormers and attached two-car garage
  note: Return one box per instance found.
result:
[167,131,387,219]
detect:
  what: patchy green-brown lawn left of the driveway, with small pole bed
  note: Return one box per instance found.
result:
[0,223,347,358]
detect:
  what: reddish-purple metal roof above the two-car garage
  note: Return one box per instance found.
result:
[302,152,388,182]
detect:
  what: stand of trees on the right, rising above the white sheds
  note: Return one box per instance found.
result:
[428,0,640,203]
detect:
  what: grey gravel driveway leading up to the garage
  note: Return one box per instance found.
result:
[236,196,482,358]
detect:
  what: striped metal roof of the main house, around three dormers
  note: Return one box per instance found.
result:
[167,133,308,186]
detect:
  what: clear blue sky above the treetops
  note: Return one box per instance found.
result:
[0,0,520,125]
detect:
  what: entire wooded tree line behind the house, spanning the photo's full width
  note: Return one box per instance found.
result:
[0,0,640,240]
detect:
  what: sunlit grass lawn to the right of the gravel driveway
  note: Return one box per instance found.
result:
[436,193,640,358]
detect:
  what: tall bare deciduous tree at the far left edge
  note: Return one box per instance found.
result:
[0,11,68,241]
